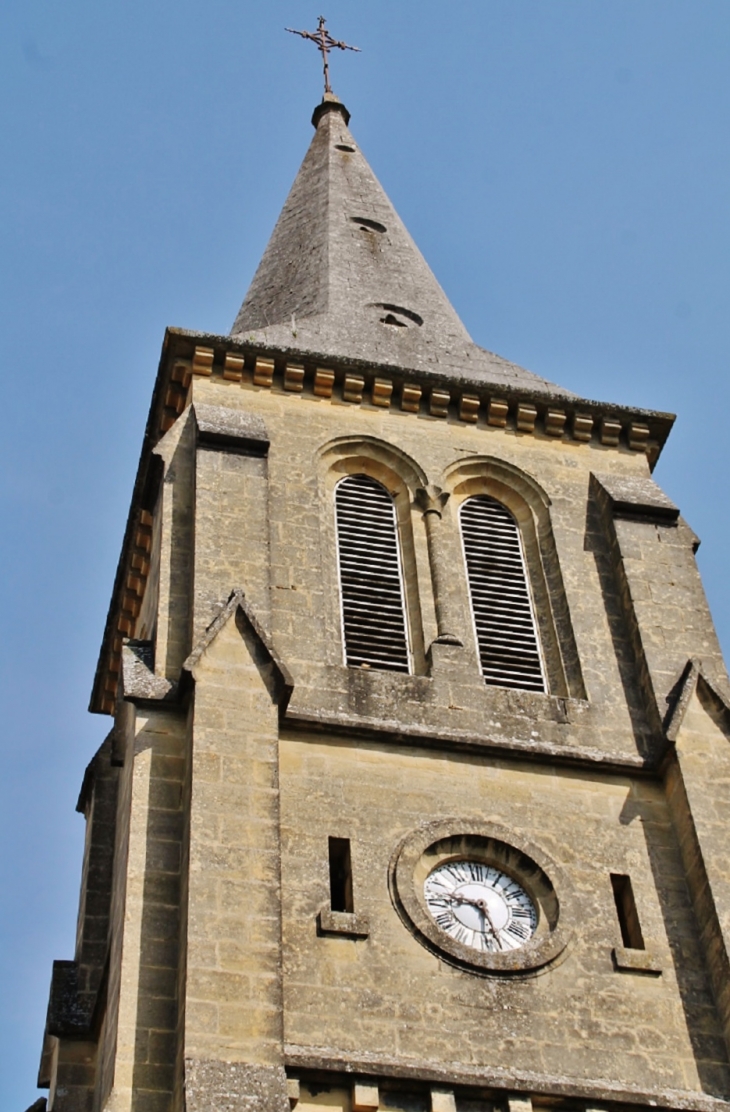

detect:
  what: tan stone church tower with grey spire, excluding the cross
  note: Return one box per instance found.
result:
[39,95,730,1112]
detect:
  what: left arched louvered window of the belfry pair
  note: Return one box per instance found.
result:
[335,475,411,672]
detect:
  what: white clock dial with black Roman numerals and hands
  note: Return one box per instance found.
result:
[423,861,537,953]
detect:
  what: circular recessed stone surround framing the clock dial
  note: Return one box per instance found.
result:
[389,818,572,974]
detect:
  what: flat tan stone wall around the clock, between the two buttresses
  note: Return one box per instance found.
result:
[282,733,730,1096]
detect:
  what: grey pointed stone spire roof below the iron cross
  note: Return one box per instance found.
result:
[231,95,569,394]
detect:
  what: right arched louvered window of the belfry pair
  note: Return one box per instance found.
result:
[460,494,545,692]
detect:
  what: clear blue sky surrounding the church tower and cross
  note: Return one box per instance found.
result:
[0,0,730,1112]
